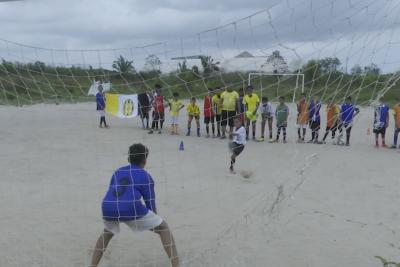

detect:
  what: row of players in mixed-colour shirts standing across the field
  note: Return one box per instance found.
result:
[97,85,400,148]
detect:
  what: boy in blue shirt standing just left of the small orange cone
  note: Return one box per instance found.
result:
[337,96,360,146]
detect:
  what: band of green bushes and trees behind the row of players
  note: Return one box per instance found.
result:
[0,57,400,105]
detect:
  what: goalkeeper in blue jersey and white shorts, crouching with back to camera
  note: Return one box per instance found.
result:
[91,144,179,267]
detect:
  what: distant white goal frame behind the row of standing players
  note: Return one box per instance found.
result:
[247,72,304,102]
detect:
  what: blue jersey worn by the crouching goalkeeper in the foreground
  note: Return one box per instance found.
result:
[102,164,156,221]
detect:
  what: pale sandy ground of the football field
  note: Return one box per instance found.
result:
[0,103,400,267]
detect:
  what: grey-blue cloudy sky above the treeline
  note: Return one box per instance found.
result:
[0,0,400,71]
